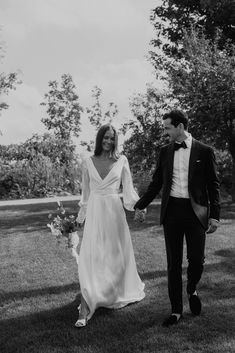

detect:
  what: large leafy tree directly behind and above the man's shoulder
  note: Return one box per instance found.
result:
[168,29,235,201]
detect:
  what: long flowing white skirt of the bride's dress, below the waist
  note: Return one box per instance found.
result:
[78,193,145,319]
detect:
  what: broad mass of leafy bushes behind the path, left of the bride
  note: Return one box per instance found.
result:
[0,133,81,198]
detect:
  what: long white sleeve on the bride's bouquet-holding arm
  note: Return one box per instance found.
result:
[77,161,90,223]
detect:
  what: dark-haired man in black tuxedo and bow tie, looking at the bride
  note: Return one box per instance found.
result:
[134,110,220,327]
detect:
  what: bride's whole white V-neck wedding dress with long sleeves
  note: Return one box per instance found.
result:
[78,156,145,319]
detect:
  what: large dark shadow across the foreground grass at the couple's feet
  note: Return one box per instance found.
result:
[0,288,234,353]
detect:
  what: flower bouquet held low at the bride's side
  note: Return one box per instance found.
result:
[47,201,79,248]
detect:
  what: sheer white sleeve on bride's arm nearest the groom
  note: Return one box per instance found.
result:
[122,156,139,211]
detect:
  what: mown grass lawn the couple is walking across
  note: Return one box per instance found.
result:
[0,201,235,353]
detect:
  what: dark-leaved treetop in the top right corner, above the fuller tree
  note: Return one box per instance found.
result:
[150,0,235,71]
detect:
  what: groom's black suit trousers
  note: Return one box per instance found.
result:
[163,197,205,314]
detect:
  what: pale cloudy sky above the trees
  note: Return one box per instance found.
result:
[0,0,161,144]
